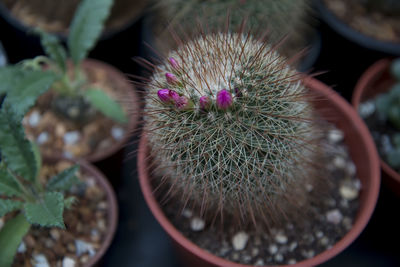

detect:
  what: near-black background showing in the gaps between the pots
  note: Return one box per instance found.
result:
[0,1,400,267]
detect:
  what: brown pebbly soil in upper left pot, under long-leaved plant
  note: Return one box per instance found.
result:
[23,61,134,161]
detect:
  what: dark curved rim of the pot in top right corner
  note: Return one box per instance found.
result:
[314,0,400,56]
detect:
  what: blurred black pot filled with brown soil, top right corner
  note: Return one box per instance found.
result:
[314,0,400,55]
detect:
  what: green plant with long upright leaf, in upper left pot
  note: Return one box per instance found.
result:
[0,0,127,123]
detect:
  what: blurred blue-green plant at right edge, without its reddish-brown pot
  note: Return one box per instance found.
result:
[375,58,400,168]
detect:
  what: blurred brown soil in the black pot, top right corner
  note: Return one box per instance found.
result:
[324,0,400,43]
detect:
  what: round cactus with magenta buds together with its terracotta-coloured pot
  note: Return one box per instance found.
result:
[138,33,380,266]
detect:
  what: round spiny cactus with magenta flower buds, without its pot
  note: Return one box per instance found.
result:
[145,33,323,226]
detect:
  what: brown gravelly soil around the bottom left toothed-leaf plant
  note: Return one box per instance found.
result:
[0,161,108,267]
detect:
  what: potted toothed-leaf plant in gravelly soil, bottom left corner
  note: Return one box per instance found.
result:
[0,103,117,267]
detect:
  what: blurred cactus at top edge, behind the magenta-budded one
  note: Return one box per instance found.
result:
[155,0,310,60]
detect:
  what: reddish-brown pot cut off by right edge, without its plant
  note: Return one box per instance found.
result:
[351,58,400,194]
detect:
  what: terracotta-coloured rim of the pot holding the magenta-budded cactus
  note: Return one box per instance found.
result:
[137,77,380,267]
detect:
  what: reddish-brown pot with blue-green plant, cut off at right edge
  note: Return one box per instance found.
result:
[352,58,400,193]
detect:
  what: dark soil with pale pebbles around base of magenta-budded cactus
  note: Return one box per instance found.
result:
[158,129,361,266]
